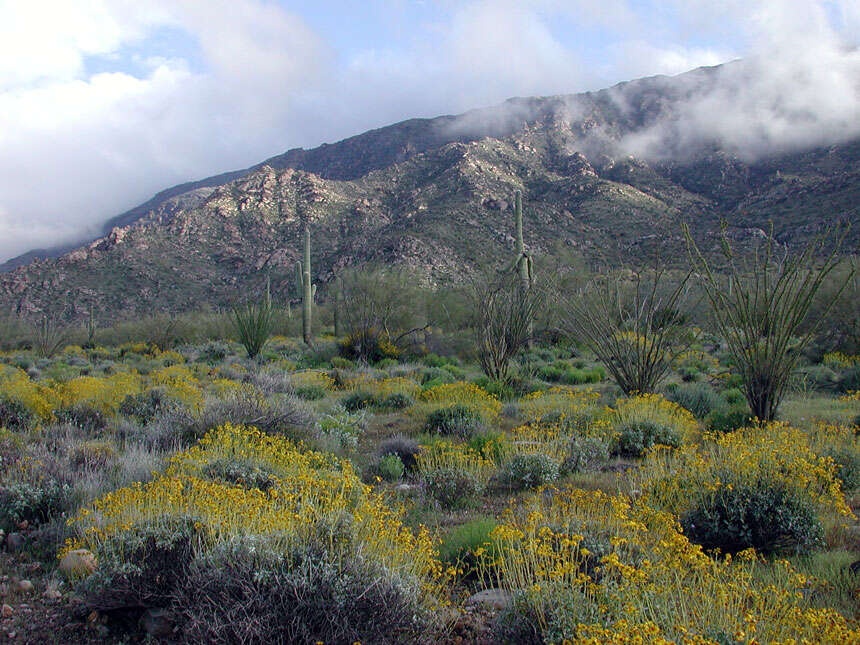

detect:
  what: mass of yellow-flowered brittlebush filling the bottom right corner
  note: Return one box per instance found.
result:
[479,489,860,645]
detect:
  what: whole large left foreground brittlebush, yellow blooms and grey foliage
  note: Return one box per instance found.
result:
[66,426,445,642]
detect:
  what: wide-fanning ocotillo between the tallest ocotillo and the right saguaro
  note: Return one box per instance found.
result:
[562,263,694,394]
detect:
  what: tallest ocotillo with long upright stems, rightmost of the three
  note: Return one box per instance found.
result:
[684,223,854,421]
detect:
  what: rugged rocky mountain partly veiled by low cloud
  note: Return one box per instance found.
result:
[0,63,860,319]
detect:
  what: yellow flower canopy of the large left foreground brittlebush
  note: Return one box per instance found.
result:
[60,424,447,604]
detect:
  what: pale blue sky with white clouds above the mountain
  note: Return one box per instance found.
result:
[0,0,860,262]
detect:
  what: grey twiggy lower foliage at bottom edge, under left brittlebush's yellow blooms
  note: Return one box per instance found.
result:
[175,542,426,644]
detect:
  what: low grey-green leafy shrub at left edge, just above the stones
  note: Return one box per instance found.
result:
[0,474,71,533]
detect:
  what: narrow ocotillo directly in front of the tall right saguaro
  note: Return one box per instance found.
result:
[471,272,547,380]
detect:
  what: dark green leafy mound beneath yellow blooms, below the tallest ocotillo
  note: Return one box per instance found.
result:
[680,477,824,554]
